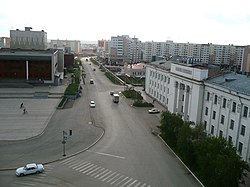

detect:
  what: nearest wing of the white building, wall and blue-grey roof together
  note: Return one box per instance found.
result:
[202,73,250,162]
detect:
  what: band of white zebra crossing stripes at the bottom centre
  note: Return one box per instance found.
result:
[60,157,151,187]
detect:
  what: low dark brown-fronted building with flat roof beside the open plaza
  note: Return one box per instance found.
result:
[0,49,63,85]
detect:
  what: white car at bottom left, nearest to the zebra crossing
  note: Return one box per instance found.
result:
[16,163,44,177]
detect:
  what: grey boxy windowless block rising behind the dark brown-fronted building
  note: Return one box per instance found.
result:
[10,27,47,50]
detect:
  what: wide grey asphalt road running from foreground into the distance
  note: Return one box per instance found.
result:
[0,57,200,187]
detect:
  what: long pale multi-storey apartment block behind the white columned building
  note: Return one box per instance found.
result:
[143,41,245,71]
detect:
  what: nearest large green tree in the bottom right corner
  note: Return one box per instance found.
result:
[194,137,249,187]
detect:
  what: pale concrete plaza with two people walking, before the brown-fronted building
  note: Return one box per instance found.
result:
[0,85,66,140]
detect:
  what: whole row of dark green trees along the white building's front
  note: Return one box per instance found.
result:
[159,112,249,187]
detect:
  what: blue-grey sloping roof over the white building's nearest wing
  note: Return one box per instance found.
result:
[205,72,250,95]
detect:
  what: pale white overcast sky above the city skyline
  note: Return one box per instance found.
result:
[0,0,250,45]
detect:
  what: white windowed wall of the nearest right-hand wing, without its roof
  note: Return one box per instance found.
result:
[202,83,250,162]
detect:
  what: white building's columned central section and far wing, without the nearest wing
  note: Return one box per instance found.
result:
[145,62,208,122]
